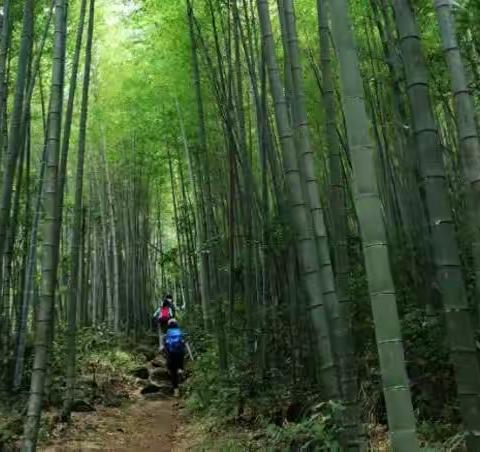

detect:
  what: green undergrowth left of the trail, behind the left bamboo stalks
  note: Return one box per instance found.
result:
[0,325,150,450]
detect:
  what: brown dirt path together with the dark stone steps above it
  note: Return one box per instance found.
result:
[39,356,183,452]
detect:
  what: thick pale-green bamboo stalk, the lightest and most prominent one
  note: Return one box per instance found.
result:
[330,0,419,452]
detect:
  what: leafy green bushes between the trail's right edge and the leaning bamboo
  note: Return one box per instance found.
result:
[184,340,342,451]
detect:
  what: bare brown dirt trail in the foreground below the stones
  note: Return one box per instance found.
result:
[39,398,179,452]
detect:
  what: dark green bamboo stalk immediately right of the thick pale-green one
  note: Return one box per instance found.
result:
[393,0,480,451]
